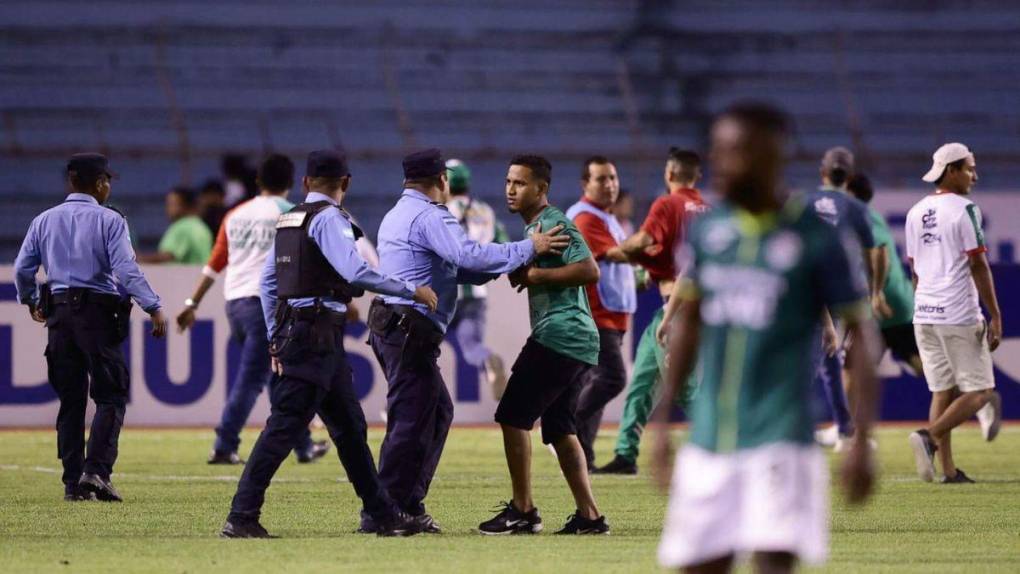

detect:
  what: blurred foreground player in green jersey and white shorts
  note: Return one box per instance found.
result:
[653,104,877,572]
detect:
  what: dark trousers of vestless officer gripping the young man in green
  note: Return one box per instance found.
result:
[368,327,453,516]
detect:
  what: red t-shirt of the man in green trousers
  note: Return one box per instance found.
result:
[634,188,708,281]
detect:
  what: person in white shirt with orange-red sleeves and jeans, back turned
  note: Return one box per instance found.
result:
[177,154,329,465]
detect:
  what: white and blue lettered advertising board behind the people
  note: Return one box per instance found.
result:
[0,193,1020,427]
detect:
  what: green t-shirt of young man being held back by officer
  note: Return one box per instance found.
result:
[524,205,599,365]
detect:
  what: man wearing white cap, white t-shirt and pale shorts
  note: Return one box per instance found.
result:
[906,144,1003,483]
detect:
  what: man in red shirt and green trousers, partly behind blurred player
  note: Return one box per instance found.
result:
[593,148,708,474]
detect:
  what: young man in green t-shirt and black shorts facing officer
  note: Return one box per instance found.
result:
[478,155,609,535]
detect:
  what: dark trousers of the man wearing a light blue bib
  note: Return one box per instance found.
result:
[575,329,627,468]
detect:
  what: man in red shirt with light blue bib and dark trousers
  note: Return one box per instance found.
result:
[566,156,638,470]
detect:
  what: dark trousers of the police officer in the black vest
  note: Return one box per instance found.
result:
[228,321,395,522]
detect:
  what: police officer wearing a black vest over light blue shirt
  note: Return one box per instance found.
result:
[220,151,436,538]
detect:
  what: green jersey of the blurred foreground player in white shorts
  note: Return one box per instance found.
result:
[684,198,868,453]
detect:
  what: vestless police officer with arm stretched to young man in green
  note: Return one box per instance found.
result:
[362,149,569,532]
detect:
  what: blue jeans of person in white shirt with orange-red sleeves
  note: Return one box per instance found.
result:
[213,297,312,453]
